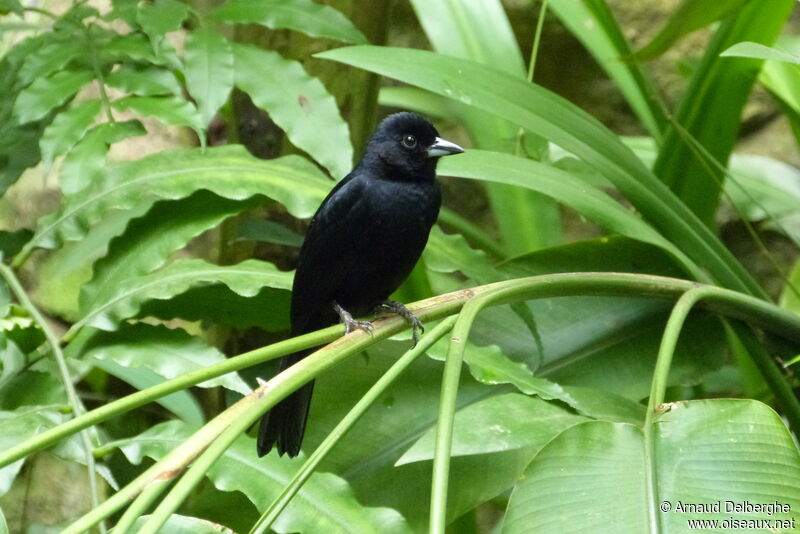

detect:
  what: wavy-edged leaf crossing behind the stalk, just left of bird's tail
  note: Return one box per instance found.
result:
[77,323,251,395]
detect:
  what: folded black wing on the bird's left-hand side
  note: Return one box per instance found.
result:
[292,174,369,335]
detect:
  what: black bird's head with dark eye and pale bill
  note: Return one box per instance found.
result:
[364,112,464,180]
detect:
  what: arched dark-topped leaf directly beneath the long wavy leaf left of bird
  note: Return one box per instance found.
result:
[81,191,259,313]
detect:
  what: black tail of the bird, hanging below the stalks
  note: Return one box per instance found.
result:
[258,351,314,457]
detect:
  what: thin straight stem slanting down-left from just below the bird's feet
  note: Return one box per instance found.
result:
[250,315,456,534]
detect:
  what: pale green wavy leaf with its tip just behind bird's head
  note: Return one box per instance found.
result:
[233,45,353,179]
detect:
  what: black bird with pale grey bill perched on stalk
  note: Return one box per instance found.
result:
[258,112,464,456]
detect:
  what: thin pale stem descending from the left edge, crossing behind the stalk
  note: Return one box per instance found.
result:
[0,263,106,532]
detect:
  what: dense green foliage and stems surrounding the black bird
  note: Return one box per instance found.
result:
[0,0,800,534]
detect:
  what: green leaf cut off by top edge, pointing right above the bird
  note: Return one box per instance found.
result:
[211,0,367,44]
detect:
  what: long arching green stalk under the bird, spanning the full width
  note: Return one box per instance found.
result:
[7,273,800,474]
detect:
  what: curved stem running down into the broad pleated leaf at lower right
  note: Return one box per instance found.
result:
[644,287,713,533]
